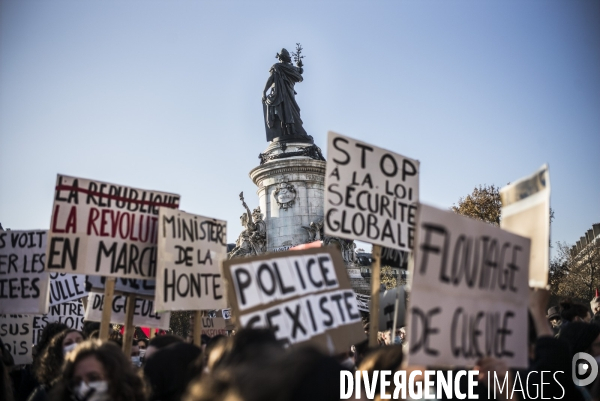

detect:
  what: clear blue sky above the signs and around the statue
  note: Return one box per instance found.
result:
[0,0,600,255]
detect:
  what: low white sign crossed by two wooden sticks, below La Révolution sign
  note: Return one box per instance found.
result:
[85,292,171,330]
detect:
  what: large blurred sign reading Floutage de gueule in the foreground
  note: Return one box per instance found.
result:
[408,204,530,368]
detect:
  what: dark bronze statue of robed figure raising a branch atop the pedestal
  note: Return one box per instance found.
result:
[262,44,313,143]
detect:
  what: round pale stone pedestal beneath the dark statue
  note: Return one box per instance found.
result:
[250,142,325,252]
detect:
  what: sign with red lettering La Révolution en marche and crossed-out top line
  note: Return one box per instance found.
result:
[46,175,179,279]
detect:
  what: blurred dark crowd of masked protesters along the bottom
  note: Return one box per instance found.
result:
[0,291,600,401]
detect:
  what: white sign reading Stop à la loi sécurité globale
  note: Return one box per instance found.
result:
[324,132,419,251]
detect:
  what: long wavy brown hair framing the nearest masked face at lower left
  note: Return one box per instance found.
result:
[49,340,146,401]
